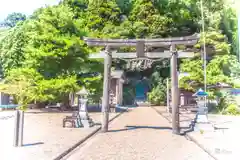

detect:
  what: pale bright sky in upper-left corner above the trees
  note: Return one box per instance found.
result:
[0,0,60,21]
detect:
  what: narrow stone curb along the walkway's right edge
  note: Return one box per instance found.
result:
[151,106,218,160]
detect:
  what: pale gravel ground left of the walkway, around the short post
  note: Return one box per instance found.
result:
[0,111,116,160]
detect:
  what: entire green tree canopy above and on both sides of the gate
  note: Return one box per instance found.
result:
[0,0,237,108]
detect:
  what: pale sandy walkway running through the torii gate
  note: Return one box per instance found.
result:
[62,107,212,160]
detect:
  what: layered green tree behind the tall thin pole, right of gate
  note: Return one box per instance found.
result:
[180,31,231,90]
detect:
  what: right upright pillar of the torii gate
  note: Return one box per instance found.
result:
[171,45,180,134]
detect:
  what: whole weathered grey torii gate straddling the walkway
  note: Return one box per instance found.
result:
[84,34,199,134]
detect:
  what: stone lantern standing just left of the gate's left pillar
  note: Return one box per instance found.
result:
[76,88,93,128]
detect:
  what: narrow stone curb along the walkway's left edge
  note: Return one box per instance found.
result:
[53,109,128,160]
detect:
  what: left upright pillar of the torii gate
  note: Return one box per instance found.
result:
[101,46,112,133]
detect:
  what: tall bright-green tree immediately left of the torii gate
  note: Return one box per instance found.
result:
[23,4,102,105]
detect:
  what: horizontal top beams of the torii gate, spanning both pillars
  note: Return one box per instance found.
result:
[84,33,200,59]
